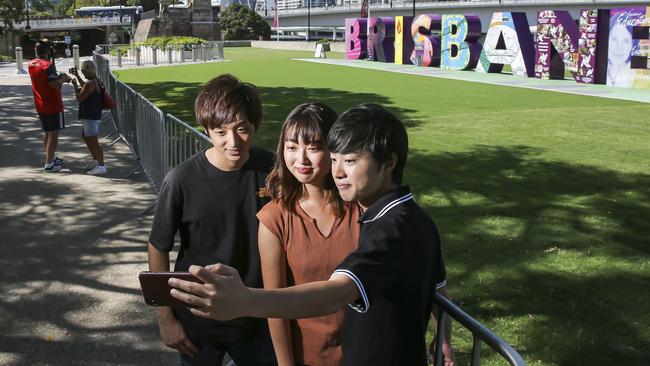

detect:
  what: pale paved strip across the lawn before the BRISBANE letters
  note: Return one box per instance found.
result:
[301,58,650,103]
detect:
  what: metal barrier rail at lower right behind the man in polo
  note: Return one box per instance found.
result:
[433,293,526,366]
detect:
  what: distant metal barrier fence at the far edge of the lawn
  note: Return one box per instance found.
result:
[95,41,224,67]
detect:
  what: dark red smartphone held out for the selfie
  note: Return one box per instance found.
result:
[138,271,203,308]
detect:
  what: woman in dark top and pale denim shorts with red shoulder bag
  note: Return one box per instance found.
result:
[69,60,107,175]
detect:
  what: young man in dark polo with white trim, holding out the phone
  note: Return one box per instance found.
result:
[170,104,453,365]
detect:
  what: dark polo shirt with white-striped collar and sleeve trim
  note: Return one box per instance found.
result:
[334,187,445,365]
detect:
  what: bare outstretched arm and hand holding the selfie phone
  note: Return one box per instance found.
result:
[169,264,359,320]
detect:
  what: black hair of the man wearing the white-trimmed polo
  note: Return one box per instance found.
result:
[327,103,408,185]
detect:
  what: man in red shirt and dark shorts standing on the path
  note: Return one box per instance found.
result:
[27,42,70,172]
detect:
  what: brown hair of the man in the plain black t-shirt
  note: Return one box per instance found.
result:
[194,74,262,132]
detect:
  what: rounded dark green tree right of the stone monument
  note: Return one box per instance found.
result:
[219,4,271,40]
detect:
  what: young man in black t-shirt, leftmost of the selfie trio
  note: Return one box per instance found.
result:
[148,75,275,366]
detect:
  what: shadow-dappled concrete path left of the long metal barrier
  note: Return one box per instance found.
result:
[0,61,178,366]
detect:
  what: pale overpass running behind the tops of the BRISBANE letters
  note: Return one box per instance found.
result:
[256,0,650,33]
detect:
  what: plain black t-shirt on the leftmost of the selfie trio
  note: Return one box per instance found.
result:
[149,147,273,342]
